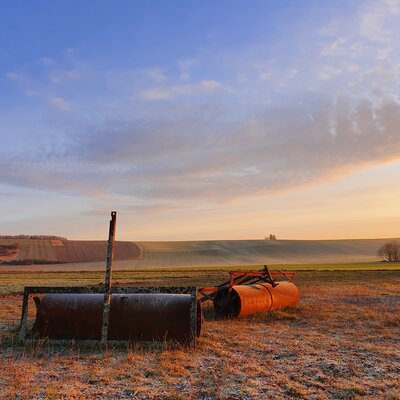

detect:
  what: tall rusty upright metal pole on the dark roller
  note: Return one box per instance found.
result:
[101,211,117,345]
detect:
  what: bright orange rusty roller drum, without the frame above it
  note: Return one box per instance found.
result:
[214,281,299,318]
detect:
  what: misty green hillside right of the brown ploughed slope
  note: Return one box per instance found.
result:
[132,239,396,267]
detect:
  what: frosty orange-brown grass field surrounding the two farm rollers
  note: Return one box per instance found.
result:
[0,264,400,400]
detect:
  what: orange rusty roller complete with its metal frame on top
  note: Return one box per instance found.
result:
[199,266,300,318]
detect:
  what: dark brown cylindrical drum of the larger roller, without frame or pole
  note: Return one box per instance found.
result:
[32,294,202,343]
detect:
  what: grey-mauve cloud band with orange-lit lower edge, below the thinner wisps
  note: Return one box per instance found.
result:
[0,86,400,207]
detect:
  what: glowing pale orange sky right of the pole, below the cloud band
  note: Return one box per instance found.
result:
[108,161,400,240]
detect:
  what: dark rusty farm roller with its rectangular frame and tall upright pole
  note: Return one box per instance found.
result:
[19,211,202,346]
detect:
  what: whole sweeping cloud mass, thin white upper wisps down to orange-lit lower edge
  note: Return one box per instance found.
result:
[4,3,400,212]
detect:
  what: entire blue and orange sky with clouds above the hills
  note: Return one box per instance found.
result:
[0,0,400,240]
